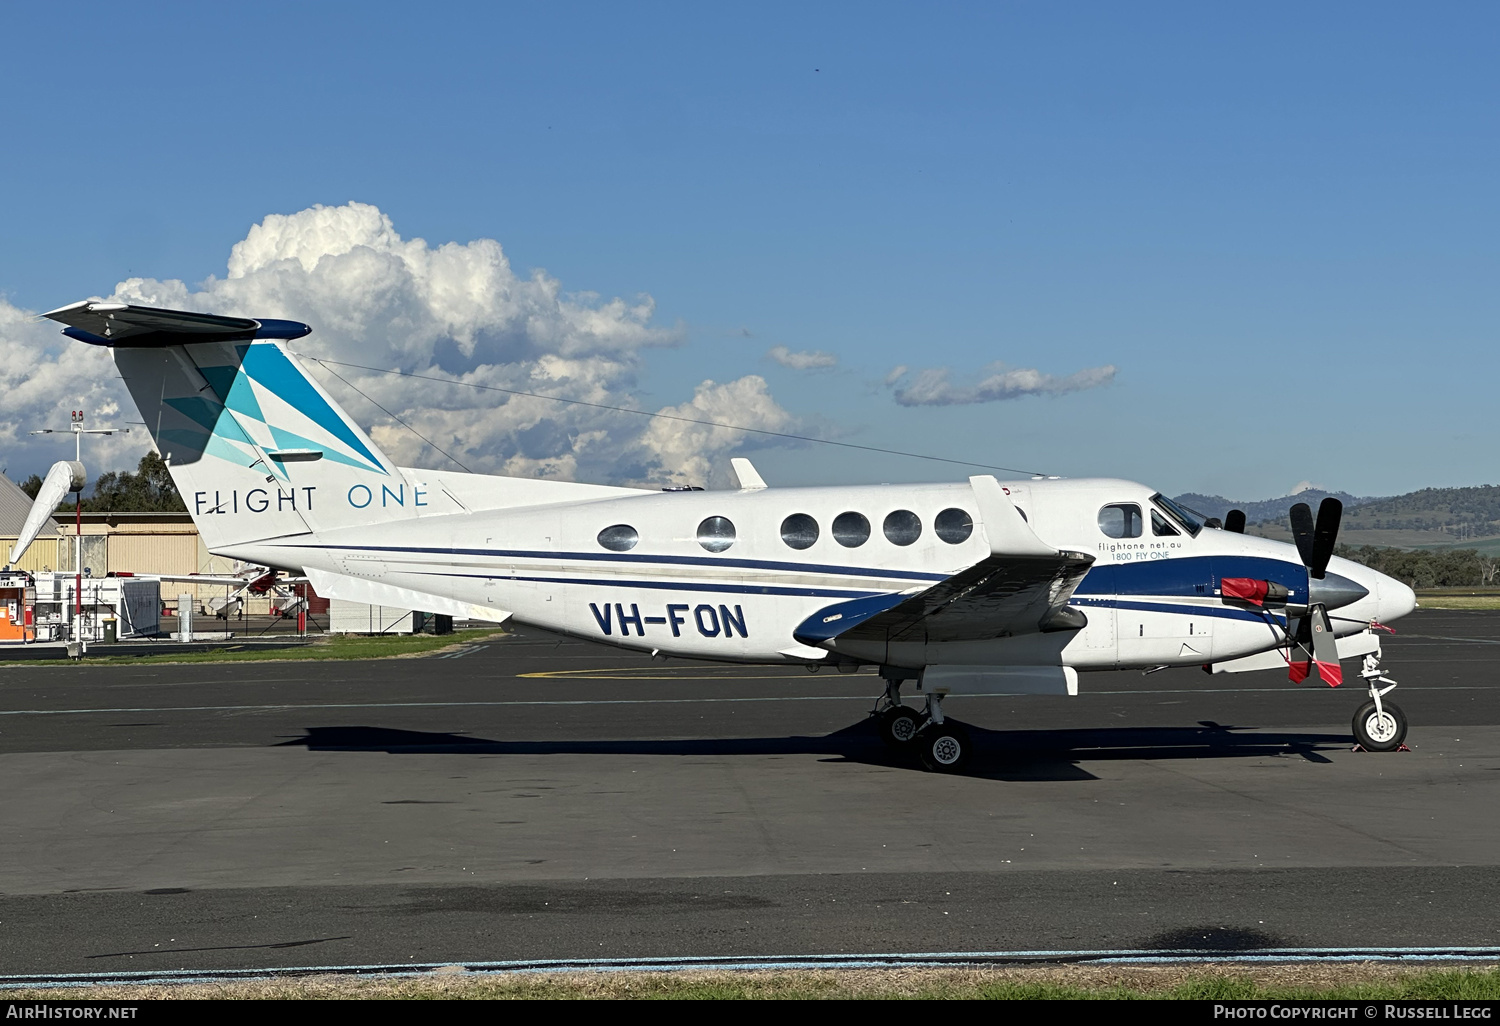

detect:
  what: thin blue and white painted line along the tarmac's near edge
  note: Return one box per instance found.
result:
[0,945,1500,990]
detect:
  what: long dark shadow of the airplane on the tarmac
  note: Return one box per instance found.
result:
[278,719,1350,780]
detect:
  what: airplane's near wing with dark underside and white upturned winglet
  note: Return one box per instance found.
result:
[794,477,1094,645]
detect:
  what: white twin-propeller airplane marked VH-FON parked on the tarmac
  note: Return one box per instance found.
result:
[35,300,1416,773]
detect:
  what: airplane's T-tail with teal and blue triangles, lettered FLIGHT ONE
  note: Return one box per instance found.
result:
[45,302,446,551]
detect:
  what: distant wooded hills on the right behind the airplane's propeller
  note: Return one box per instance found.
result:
[1178,485,1500,555]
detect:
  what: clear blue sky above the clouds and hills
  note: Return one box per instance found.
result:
[0,3,1500,498]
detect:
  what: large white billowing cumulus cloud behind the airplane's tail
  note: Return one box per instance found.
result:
[0,203,792,485]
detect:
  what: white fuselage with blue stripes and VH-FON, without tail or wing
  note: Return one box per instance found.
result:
[230,479,1415,669]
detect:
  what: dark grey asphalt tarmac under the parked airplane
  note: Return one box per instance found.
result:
[0,611,1500,975]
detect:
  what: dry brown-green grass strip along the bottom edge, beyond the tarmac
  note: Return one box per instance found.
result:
[5,963,1500,1001]
